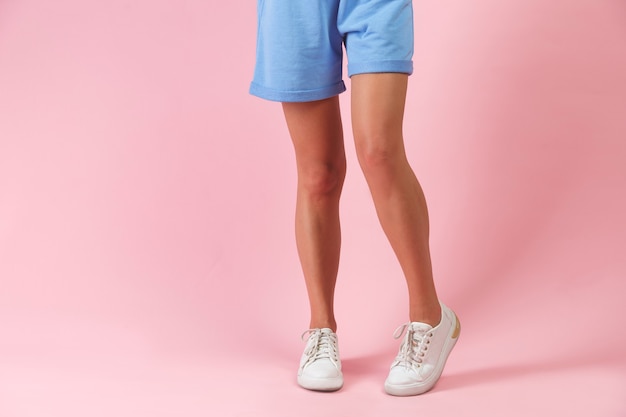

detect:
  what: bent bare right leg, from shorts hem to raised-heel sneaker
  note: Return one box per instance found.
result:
[352,74,441,326]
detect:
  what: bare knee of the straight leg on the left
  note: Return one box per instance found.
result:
[298,161,346,198]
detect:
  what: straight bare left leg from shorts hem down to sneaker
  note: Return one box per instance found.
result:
[283,97,346,331]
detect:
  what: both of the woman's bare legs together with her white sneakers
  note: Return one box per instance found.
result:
[283,78,460,396]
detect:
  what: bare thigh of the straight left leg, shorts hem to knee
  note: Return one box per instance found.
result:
[283,96,345,168]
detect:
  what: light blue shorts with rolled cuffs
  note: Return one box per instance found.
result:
[250,0,414,102]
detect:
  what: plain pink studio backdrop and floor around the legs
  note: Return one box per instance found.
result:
[0,0,626,417]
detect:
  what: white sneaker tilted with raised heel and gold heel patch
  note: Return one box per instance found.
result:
[385,304,461,396]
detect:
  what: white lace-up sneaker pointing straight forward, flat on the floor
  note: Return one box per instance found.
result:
[298,328,343,391]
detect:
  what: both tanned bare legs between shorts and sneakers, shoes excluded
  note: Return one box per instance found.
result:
[283,74,441,330]
